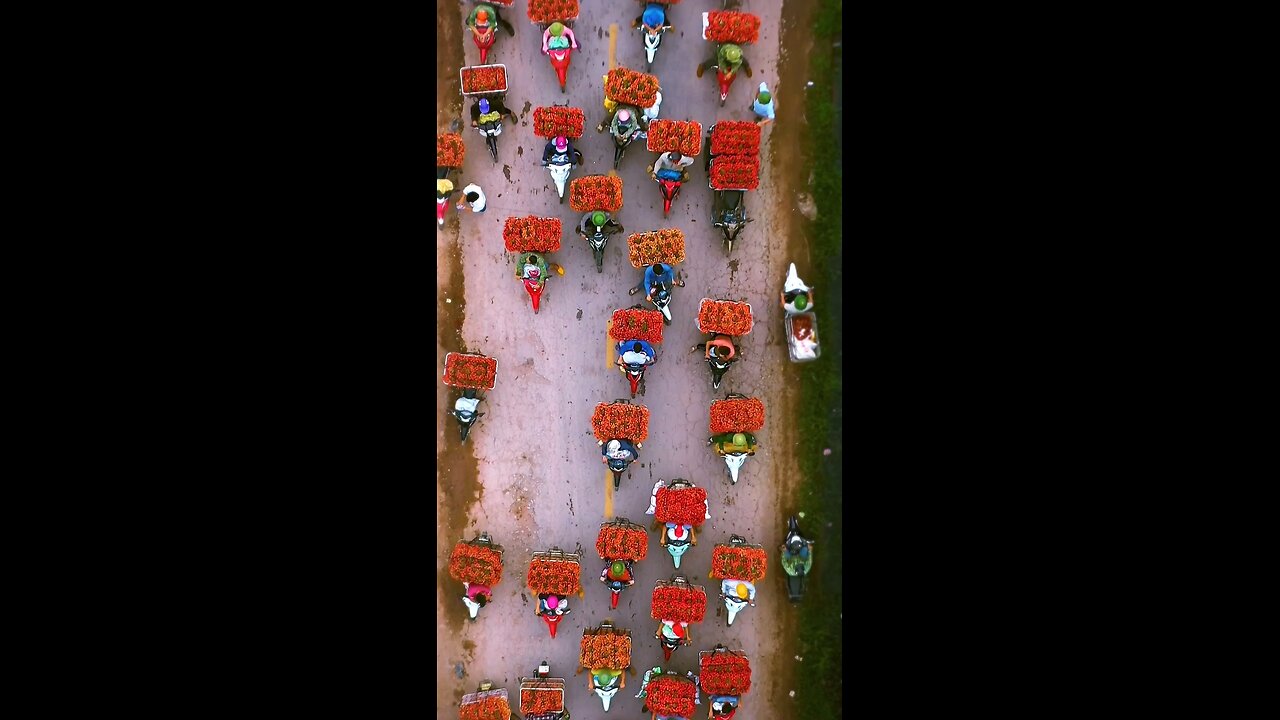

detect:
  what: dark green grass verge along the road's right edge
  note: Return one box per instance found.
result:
[786,0,844,719]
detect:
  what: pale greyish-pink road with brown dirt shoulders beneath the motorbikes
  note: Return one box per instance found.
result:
[434,0,809,717]
